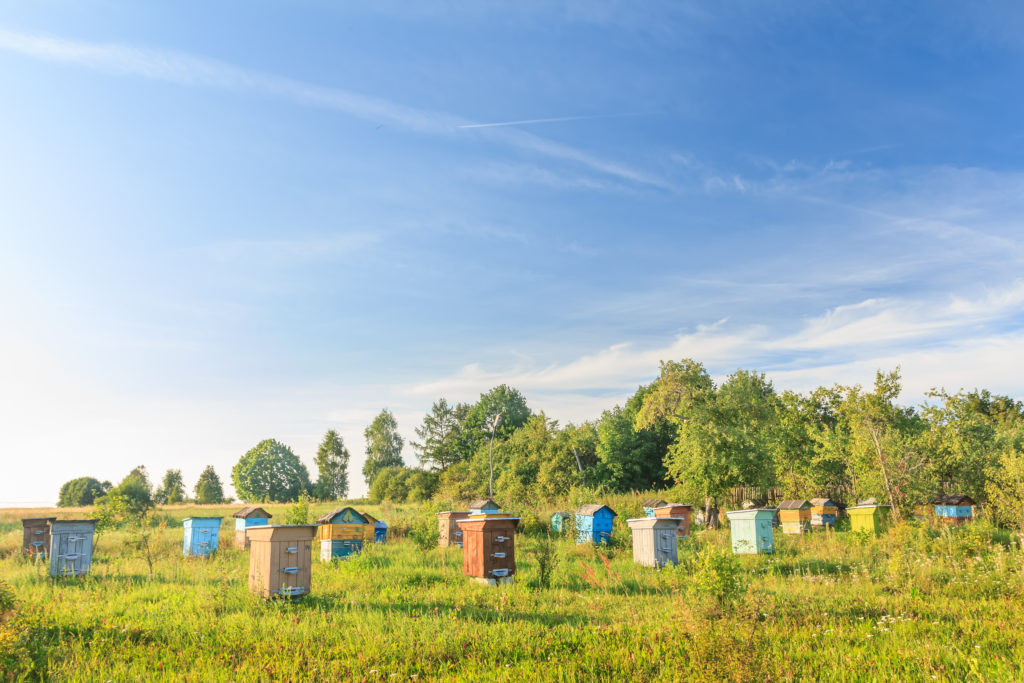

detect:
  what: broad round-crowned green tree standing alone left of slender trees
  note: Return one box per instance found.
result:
[231,438,309,503]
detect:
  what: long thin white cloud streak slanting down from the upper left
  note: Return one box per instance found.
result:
[0,29,671,188]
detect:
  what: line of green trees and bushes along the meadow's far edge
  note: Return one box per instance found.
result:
[60,359,1024,540]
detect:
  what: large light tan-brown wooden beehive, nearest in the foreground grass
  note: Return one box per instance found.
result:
[248,524,316,598]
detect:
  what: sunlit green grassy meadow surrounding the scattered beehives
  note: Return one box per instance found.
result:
[0,497,1024,681]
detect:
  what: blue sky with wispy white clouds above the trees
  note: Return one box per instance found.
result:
[0,0,1024,502]
